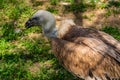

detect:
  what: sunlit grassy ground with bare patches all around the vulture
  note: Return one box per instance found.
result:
[0,0,120,80]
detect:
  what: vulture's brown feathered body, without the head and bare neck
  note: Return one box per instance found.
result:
[52,19,120,80]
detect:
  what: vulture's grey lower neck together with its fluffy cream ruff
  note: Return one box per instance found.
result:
[43,20,75,38]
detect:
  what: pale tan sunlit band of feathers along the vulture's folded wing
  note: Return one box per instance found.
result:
[83,38,120,62]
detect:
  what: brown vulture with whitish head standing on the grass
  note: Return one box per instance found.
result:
[25,10,120,80]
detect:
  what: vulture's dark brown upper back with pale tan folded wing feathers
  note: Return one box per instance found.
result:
[63,26,120,62]
